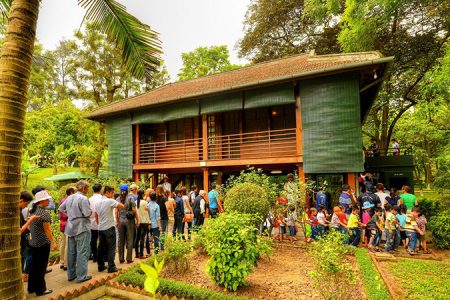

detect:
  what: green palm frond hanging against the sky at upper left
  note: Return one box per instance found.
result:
[78,0,162,78]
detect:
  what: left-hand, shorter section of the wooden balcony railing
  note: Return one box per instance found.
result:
[139,138,203,164]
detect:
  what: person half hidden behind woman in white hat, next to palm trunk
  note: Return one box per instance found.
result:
[19,191,40,281]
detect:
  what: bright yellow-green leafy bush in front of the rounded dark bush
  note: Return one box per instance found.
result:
[201,212,272,291]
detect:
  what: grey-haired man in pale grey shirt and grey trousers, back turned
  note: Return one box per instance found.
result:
[59,180,92,282]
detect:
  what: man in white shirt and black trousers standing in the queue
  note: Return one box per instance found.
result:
[94,186,124,273]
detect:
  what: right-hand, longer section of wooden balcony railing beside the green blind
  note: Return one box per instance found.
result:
[208,128,297,160]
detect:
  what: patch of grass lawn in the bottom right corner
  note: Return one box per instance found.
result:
[386,259,450,300]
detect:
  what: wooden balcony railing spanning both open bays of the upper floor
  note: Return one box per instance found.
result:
[139,128,297,164]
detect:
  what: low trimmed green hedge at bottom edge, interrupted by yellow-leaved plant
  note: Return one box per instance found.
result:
[116,267,245,300]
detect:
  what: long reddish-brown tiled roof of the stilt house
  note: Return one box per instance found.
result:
[88,52,389,120]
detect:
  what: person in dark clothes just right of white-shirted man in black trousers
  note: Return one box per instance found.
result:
[116,184,139,264]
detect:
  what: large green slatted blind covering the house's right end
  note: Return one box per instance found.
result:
[300,73,364,174]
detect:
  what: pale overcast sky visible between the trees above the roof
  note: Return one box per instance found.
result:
[37,0,250,81]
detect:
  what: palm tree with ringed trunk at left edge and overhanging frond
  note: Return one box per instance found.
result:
[0,0,161,299]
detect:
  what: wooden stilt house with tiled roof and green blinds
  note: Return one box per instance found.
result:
[89,52,393,190]
